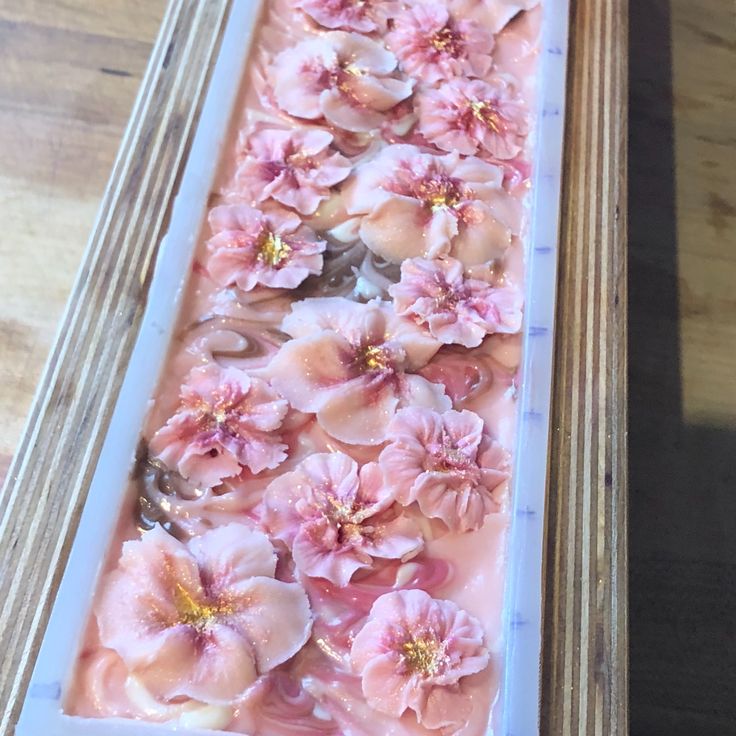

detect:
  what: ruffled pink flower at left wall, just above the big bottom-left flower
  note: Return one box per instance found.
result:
[151,364,288,487]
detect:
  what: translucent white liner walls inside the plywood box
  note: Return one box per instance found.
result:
[16,0,569,736]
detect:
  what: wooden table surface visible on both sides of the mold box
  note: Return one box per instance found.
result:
[0,0,736,736]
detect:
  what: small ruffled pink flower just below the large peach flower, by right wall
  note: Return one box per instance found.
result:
[389,258,521,348]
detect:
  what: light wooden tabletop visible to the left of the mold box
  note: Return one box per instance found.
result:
[0,0,166,492]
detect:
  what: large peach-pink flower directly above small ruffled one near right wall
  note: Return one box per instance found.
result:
[343,144,520,266]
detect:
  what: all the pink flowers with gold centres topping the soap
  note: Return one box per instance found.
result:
[92,0,527,729]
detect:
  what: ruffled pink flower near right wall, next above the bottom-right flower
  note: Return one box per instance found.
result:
[378,407,508,532]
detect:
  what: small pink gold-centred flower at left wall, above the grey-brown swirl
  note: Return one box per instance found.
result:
[207,205,326,291]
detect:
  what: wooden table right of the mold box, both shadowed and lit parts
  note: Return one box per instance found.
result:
[629,0,736,736]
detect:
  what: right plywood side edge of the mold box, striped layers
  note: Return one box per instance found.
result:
[542,0,628,736]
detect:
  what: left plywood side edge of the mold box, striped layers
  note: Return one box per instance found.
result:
[0,0,229,735]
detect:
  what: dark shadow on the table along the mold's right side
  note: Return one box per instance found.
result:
[629,0,736,736]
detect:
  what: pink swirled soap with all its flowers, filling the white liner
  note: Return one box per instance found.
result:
[65,0,540,736]
